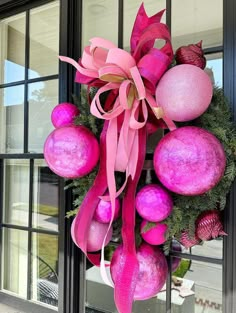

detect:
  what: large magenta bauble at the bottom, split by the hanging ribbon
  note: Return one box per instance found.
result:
[111,243,168,300]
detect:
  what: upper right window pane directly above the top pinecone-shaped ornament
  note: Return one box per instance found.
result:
[171,0,223,49]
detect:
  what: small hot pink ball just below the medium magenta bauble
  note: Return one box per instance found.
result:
[140,221,168,245]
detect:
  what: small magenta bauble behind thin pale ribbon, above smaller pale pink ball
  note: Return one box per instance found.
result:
[93,199,120,223]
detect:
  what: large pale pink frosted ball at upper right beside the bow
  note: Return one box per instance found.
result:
[156,64,213,122]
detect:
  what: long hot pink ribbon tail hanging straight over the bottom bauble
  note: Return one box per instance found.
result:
[114,127,146,313]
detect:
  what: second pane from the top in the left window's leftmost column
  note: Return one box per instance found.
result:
[0,85,24,153]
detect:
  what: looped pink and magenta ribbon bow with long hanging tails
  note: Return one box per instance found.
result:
[60,4,175,313]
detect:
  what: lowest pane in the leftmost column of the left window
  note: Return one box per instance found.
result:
[2,229,28,298]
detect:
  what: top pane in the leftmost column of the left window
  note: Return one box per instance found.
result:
[0,13,25,84]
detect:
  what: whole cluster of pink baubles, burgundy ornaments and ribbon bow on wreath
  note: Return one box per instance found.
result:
[44,5,234,313]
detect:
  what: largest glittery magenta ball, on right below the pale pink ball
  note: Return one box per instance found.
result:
[153,126,226,196]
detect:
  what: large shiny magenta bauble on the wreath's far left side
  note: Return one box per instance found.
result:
[44,126,99,178]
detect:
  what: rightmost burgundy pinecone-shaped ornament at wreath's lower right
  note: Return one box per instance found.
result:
[196,210,227,240]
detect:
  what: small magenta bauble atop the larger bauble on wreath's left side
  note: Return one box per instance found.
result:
[51,102,80,128]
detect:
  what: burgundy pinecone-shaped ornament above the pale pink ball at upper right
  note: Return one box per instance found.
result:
[175,41,206,69]
